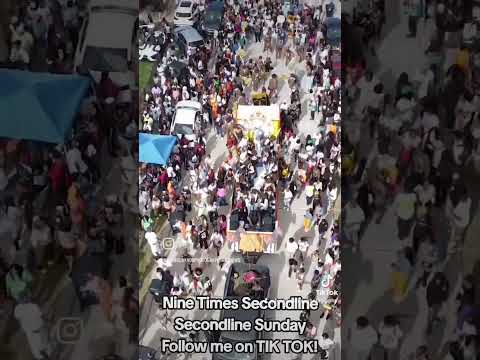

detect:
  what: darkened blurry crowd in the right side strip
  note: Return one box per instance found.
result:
[342,1,480,360]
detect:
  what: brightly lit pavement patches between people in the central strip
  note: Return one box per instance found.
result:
[140,1,340,360]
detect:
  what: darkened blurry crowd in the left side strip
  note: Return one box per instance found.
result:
[0,0,138,359]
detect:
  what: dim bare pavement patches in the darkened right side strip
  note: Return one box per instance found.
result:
[342,1,480,360]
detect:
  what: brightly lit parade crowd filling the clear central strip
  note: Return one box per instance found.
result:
[139,1,341,354]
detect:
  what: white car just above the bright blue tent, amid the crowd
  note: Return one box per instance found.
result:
[170,100,203,140]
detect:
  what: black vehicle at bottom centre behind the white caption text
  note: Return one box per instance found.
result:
[212,263,270,360]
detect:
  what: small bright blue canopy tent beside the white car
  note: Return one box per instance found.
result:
[138,133,177,165]
